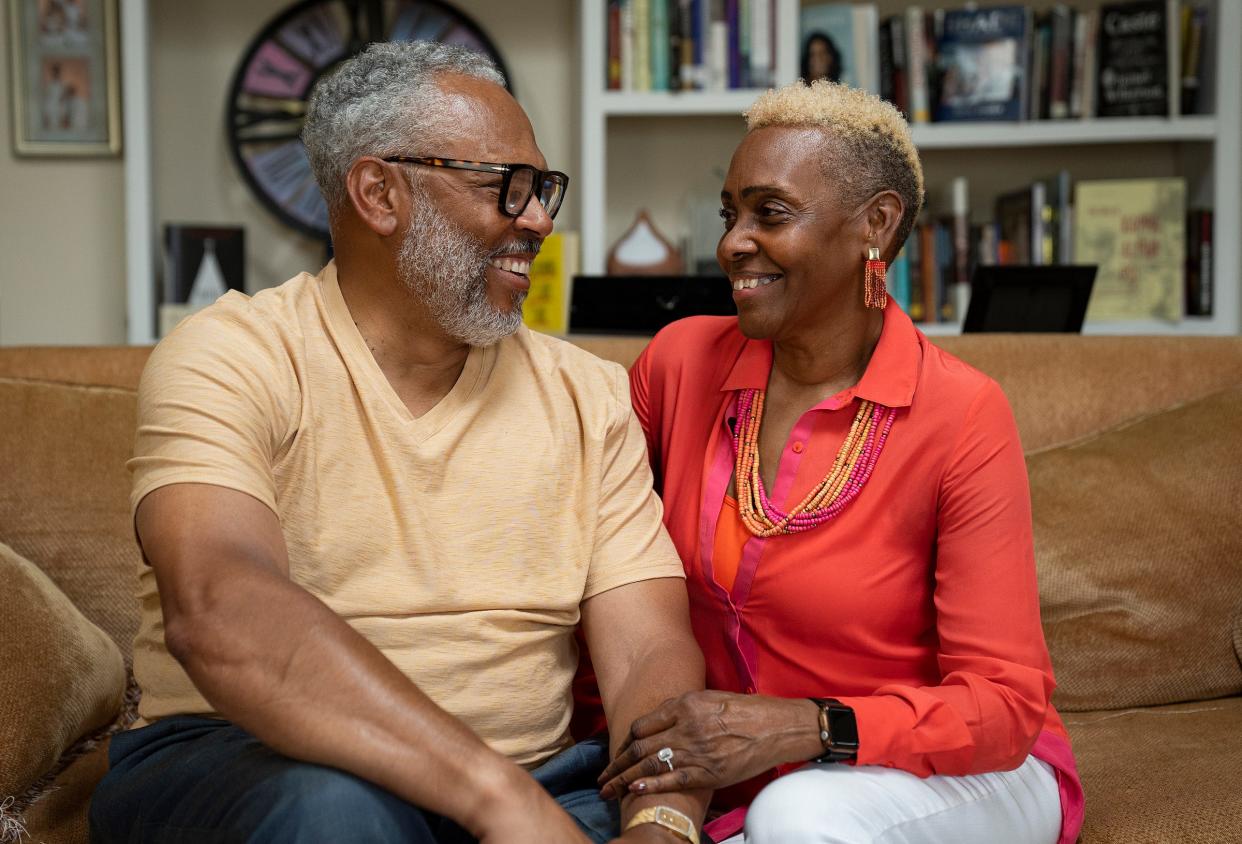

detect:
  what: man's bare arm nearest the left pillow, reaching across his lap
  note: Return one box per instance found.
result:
[135,484,585,844]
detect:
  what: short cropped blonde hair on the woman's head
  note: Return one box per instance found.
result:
[744,79,924,254]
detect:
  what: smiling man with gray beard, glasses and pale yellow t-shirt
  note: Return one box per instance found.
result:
[91,43,707,844]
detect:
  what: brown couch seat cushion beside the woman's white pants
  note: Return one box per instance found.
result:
[1066,698,1242,844]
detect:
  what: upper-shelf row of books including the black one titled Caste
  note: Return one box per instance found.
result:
[801,0,1217,123]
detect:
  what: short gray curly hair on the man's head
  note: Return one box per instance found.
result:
[302,41,504,216]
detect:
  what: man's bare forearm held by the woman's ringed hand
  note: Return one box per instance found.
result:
[582,577,712,842]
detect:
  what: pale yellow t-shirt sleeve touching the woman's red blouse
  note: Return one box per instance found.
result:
[582,366,686,599]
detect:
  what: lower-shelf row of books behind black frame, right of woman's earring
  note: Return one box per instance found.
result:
[889,176,1213,323]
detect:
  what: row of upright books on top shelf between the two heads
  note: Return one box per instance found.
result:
[605,0,776,91]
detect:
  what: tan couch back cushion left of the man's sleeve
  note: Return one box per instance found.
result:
[0,377,140,654]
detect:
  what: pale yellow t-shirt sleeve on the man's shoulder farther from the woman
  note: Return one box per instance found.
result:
[128,297,297,511]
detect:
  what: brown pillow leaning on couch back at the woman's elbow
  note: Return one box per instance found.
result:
[1027,388,1242,711]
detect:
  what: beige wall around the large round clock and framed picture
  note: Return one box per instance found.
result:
[0,0,578,345]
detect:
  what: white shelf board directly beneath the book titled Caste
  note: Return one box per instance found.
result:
[913,117,1217,149]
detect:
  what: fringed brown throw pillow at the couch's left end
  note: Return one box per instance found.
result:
[0,544,125,799]
